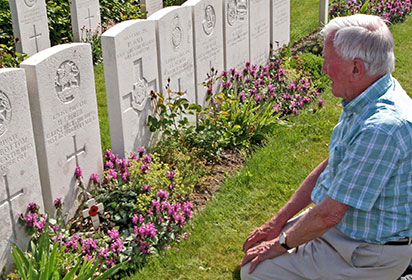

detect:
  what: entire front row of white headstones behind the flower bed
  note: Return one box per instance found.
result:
[0,0,289,268]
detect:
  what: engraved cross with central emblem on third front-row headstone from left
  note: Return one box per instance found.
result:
[123,58,157,113]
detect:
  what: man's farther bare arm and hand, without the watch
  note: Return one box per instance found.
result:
[243,159,328,252]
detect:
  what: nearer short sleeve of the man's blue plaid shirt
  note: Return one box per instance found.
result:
[328,128,400,211]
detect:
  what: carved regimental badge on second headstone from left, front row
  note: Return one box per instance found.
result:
[54,60,80,103]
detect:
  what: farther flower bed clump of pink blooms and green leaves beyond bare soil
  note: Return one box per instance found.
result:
[148,49,326,161]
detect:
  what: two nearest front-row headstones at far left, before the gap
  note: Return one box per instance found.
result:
[0,43,103,270]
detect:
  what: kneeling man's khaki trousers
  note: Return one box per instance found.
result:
[240,211,412,280]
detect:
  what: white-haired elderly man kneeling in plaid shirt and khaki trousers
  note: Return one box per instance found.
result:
[241,15,412,280]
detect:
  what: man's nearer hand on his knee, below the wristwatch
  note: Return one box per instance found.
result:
[240,238,287,273]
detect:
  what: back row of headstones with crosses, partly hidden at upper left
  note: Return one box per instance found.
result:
[9,0,163,56]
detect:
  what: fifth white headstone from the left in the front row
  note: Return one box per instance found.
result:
[183,0,223,106]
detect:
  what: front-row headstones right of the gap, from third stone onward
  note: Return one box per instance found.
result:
[102,0,290,158]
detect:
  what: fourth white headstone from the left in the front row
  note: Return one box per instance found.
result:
[148,6,196,106]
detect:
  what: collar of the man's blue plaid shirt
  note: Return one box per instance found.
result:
[342,74,393,113]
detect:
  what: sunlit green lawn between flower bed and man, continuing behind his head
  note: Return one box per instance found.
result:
[125,9,412,279]
